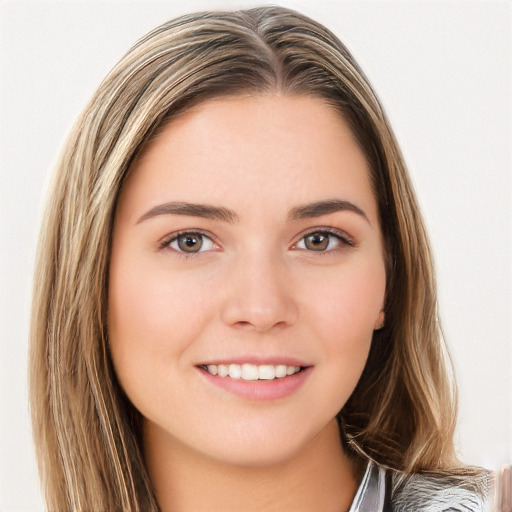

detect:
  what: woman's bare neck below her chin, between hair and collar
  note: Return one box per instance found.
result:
[144,420,359,512]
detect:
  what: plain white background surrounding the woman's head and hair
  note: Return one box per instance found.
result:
[0,0,512,512]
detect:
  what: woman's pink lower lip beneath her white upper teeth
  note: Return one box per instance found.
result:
[199,366,313,402]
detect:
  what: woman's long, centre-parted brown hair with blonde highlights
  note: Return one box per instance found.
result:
[30,7,455,511]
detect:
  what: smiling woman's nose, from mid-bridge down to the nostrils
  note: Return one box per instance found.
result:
[222,251,298,333]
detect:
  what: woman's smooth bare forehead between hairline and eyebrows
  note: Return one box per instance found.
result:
[121,95,375,223]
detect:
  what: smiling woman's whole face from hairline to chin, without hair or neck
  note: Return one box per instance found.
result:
[109,95,386,465]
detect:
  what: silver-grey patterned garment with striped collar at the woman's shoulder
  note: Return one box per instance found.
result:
[349,461,493,512]
